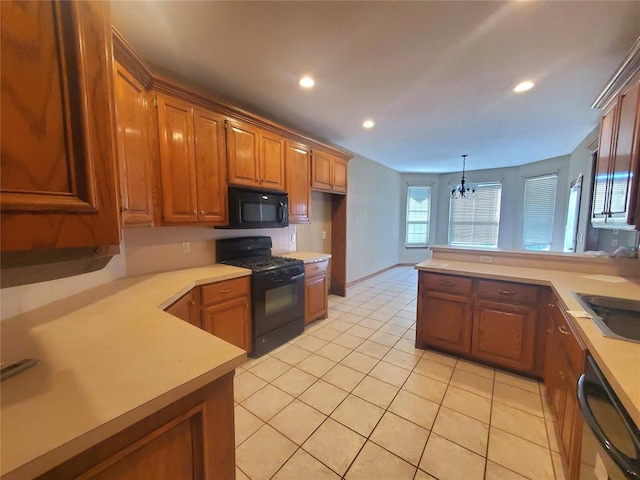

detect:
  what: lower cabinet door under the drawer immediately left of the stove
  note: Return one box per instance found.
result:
[202,297,251,352]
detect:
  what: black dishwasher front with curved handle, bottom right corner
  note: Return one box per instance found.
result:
[578,356,640,480]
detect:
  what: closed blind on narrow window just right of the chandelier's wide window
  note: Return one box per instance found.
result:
[522,173,558,250]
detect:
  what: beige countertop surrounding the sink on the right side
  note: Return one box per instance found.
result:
[416,259,640,425]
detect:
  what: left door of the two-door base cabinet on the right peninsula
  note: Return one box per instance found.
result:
[416,291,472,353]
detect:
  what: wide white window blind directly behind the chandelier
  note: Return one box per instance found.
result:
[448,182,502,248]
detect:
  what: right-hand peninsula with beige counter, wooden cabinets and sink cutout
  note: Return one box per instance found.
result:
[415,247,640,478]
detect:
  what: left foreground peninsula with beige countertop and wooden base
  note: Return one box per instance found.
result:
[0,265,250,479]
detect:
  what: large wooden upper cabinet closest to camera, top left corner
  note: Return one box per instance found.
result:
[0,1,120,252]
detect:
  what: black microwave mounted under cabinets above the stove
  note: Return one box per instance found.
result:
[228,187,289,228]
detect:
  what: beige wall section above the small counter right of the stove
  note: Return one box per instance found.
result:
[296,192,331,253]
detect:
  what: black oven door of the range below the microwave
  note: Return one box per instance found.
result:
[251,272,304,338]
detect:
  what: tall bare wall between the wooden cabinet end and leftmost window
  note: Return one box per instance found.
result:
[347,155,401,283]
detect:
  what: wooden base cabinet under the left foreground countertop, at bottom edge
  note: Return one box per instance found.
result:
[38,372,235,480]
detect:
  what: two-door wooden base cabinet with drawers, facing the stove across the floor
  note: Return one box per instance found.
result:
[416,272,546,376]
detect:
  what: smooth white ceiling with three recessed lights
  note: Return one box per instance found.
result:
[111,1,640,173]
